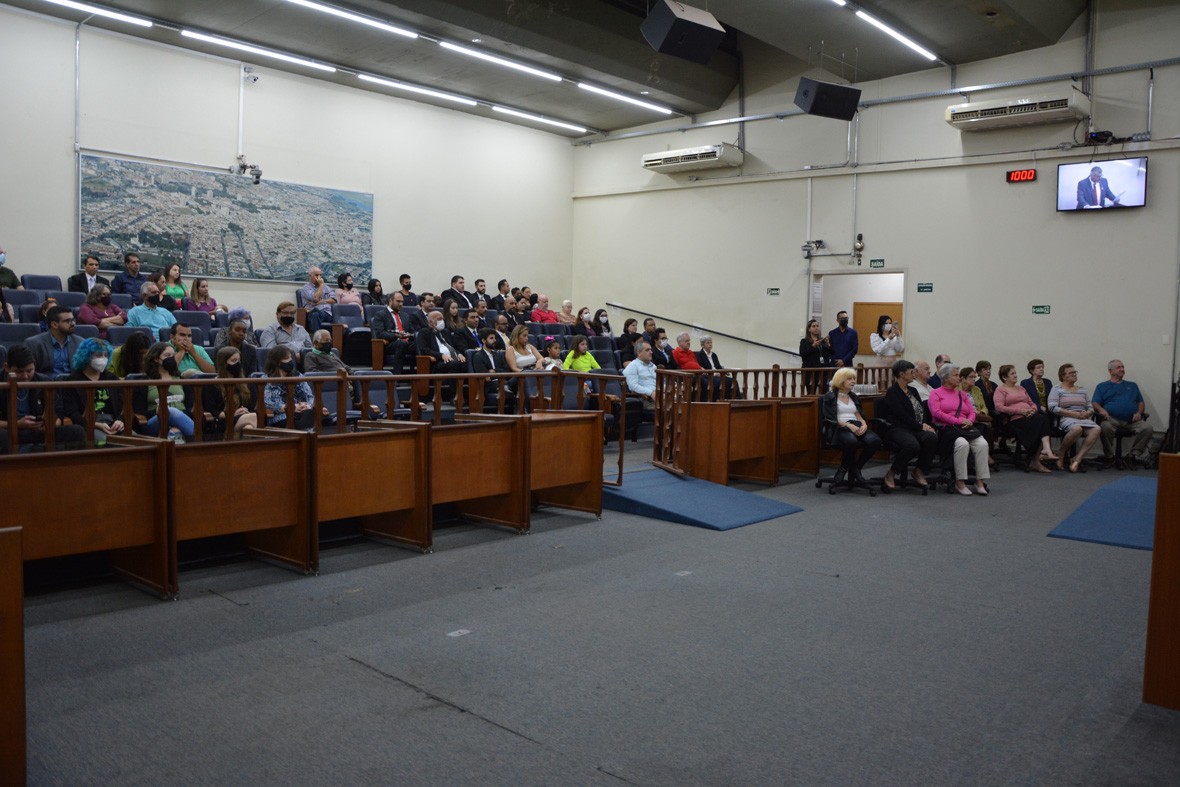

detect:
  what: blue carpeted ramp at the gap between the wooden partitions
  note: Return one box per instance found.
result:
[602,467,802,530]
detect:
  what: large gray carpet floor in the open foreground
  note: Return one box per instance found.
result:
[20,442,1180,785]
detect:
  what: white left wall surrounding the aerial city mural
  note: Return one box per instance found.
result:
[0,6,572,323]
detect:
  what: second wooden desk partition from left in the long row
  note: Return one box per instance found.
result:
[168,429,320,587]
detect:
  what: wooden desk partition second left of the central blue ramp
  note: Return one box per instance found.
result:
[430,415,528,533]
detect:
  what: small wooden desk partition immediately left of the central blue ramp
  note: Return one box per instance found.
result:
[527,411,603,517]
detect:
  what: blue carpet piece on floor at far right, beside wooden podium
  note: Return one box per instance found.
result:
[1049,476,1155,550]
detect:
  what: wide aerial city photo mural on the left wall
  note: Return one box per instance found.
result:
[78,153,373,283]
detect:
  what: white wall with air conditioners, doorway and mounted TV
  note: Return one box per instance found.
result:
[573,0,1180,415]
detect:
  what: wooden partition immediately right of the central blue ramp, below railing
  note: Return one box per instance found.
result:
[684,399,779,484]
